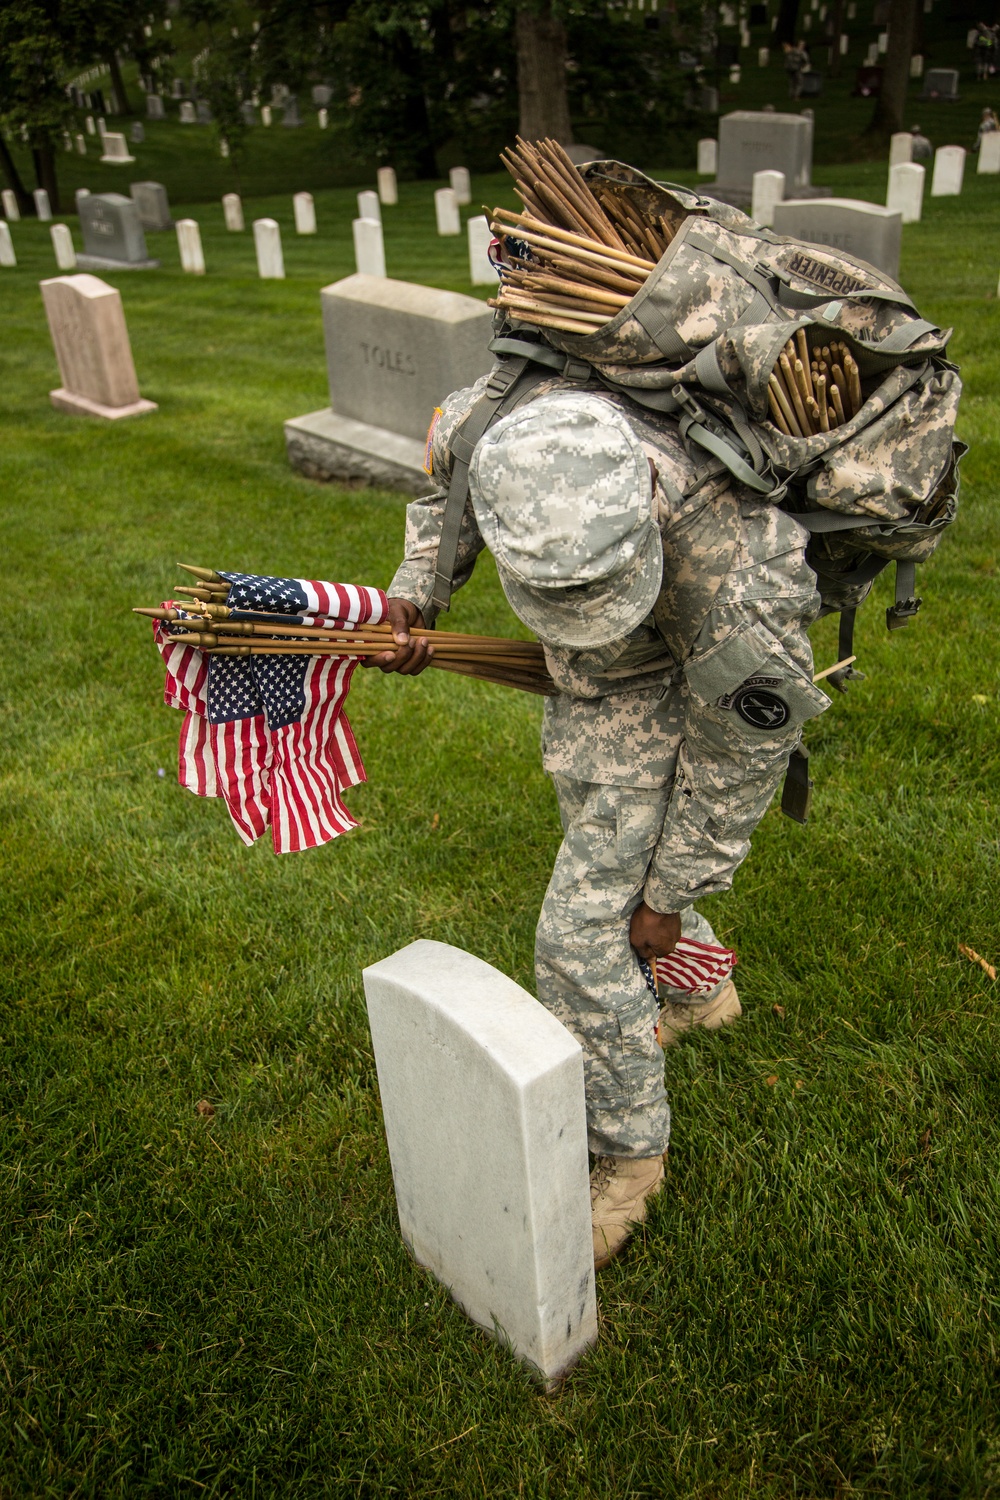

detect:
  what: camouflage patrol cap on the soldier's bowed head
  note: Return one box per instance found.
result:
[469,392,663,648]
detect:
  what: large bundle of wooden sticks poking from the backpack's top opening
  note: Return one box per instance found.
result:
[490,137,673,333]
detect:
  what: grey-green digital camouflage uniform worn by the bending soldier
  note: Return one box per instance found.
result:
[390,381,828,1157]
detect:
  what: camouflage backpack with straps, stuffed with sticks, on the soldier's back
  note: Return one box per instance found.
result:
[435,162,966,762]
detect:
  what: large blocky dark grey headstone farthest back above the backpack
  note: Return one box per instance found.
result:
[699,110,828,209]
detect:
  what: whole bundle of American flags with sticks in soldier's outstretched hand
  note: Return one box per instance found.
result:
[136,567,553,854]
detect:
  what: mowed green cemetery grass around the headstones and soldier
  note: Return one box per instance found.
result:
[0,167,1000,1500]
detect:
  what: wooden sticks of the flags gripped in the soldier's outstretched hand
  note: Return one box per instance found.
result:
[132,563,556,696]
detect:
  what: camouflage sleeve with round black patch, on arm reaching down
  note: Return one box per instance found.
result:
[643,506,829,912]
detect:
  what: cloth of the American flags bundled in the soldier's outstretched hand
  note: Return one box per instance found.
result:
[154,573,387,854]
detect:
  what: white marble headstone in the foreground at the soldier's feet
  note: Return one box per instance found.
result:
[364,941,597,1382]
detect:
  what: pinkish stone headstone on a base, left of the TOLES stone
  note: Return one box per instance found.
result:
[42,276,156,420]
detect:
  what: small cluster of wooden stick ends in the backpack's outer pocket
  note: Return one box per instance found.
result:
[768,329,864,438]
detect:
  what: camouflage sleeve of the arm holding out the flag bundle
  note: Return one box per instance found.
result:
[388,377,489,626]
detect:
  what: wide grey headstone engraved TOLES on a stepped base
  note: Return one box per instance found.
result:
[285,273,493,495]
